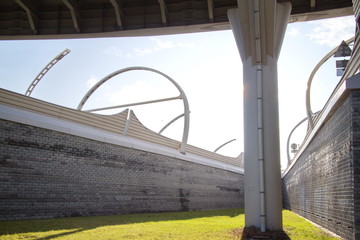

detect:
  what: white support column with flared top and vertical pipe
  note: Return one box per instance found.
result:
[228,0,291,231]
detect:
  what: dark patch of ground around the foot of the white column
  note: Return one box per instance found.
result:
[233,226,290,240]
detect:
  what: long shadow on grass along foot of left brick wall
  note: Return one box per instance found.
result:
[0,209,244,240]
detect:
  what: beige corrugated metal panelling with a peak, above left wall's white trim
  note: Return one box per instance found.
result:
[0,89,243,168]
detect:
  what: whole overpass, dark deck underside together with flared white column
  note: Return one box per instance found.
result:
[0,0,353,234]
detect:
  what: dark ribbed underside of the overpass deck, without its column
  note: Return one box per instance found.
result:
[0,0,353,39]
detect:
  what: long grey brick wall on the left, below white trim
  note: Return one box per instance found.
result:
[0,120,244,220]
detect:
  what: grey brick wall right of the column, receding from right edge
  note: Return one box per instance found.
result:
[283,91,360,239]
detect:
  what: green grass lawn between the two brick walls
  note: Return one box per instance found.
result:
[0,209,336,240]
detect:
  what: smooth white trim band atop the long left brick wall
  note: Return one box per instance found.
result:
[0,105,244,174]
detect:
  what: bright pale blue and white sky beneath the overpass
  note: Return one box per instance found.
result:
[0,16,355,168]
